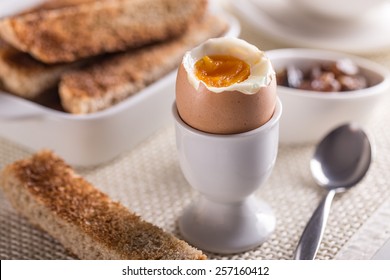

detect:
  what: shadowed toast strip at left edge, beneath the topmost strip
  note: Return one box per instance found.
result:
[0,40,83,99]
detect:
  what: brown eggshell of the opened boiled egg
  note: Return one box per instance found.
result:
[176,38,276,134]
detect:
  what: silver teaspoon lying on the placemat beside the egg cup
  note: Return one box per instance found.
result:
[294,124,372,260]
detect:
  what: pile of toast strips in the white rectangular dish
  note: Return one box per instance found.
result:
[0,0,228,114]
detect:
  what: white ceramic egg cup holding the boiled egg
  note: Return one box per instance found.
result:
[173,100,282,254]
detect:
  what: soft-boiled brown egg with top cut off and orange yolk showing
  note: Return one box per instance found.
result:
[176,37,276,134]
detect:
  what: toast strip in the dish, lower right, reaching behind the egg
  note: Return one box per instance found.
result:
[59,15,228,114]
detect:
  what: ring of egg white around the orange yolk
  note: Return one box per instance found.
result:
[182,37,275,94]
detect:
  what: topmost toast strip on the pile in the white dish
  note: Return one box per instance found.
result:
[0,0,207,63]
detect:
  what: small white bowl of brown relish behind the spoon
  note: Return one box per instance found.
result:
[267,49,390,144]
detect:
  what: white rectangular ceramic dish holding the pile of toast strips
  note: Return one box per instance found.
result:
[0,6,240,166]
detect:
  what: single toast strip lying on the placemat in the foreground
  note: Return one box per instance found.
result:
[0,151,206,260]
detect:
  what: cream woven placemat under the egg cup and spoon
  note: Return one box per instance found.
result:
[0,87,390,259]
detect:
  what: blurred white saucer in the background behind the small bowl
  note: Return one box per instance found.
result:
[230,0,390,53]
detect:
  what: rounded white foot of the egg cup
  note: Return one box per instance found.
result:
[179,196,276,254]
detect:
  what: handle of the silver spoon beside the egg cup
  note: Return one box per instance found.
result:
[294,190,336,260]
